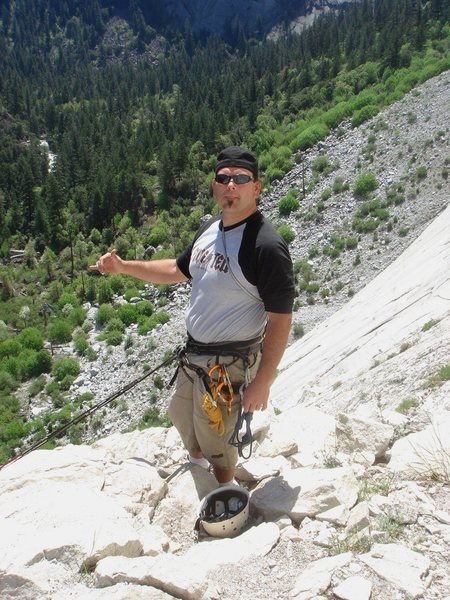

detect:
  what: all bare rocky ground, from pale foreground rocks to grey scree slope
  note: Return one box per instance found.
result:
[0,68,450,600]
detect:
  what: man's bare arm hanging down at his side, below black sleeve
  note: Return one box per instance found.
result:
[243,312,292,412]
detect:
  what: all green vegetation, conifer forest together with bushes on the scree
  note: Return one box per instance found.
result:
[0,0,450,457]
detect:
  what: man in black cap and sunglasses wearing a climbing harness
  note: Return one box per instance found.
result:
[92,146,295,485]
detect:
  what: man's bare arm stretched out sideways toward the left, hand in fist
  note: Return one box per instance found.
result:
[90,250,187,284]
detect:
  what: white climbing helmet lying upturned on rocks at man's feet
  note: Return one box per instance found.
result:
[196,485,249,538]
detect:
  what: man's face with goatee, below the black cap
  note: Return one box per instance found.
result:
[212,167,261,226]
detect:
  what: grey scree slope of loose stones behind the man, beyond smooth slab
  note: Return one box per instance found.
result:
[44,68,450,439]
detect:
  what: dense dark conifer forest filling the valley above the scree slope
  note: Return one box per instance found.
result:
[0,0,449,257]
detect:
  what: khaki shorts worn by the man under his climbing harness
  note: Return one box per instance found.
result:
[169,352,261,469]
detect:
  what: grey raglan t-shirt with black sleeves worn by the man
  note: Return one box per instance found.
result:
[177,211,295,344]
